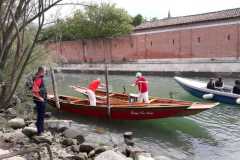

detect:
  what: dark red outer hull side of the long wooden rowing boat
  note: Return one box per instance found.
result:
[48,96,217,120]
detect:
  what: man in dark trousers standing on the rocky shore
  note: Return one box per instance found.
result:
[32,67,47,135]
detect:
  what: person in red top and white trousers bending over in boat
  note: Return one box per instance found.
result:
[87,78,103,106]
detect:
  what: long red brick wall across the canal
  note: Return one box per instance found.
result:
[47,23,240,63]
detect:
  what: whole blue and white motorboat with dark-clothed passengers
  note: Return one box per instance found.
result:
[174,77,240,105]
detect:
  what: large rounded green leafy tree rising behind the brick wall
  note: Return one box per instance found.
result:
[41,3,133,40]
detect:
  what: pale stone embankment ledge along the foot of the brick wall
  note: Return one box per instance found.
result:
[54,59,240,78]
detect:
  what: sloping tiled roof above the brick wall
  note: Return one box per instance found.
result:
[135,8,240,31]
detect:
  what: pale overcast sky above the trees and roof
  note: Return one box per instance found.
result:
[48,0,240,22]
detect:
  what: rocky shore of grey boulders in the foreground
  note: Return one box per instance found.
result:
[0,100,158,160]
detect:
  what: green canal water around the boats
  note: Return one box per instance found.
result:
[46,74,240,160]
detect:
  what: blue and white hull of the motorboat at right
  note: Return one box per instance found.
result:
[174,77,240,105]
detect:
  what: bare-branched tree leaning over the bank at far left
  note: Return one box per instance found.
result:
[0,0,62,108]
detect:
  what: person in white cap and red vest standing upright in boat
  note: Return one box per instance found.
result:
[133,72,149,103]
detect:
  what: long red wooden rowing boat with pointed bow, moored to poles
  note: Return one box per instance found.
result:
[48,85,218,120]
